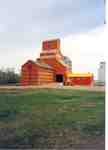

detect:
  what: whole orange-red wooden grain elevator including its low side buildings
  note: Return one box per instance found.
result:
[21,39,93,86]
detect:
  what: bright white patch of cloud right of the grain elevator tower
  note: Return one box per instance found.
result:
[61,25,108,79]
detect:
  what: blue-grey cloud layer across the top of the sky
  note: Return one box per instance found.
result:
[0,0,105,48]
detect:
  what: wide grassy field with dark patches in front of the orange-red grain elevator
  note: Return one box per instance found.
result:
[0,89,105,148]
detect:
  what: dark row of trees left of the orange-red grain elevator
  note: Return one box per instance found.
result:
[0,68,20,85]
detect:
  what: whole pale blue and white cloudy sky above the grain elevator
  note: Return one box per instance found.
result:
[0,0,108,78]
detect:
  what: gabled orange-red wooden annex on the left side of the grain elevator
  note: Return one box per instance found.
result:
[21,60,54,86]
